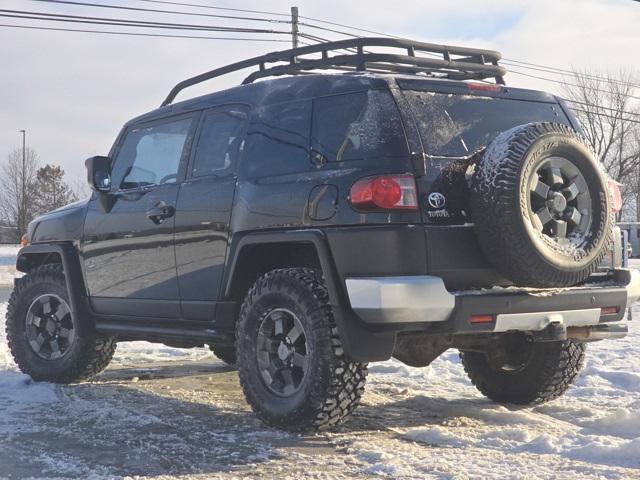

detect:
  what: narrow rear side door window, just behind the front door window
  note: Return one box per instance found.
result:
[192,110,245,177]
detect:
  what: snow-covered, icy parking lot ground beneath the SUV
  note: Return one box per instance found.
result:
[0,253,640,479]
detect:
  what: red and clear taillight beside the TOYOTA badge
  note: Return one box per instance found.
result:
[349,175,418,211]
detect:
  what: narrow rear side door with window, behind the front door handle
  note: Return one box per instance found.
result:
[175,106,246,320]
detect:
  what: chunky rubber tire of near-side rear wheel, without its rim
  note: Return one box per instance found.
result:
[236,268,367,431]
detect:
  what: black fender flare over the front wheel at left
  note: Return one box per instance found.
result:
[16,242,90,318]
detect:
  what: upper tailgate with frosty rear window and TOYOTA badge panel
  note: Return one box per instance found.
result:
[398,80,569,225]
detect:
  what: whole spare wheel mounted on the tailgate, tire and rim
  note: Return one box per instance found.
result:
[471,123,613,287]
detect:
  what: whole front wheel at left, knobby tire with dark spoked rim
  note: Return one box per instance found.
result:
[6,265,116,383]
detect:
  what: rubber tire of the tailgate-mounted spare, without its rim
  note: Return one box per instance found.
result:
[470,123,613,287]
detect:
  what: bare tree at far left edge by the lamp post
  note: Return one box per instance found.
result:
[0,148,38,242]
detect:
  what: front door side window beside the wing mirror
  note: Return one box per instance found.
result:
[112,118,192,189]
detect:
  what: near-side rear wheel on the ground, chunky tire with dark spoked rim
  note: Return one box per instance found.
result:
[236,268,367,431]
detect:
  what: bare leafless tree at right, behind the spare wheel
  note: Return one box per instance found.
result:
[563,70,640,219]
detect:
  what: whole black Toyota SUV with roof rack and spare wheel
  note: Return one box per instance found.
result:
[7,38,640,430]
